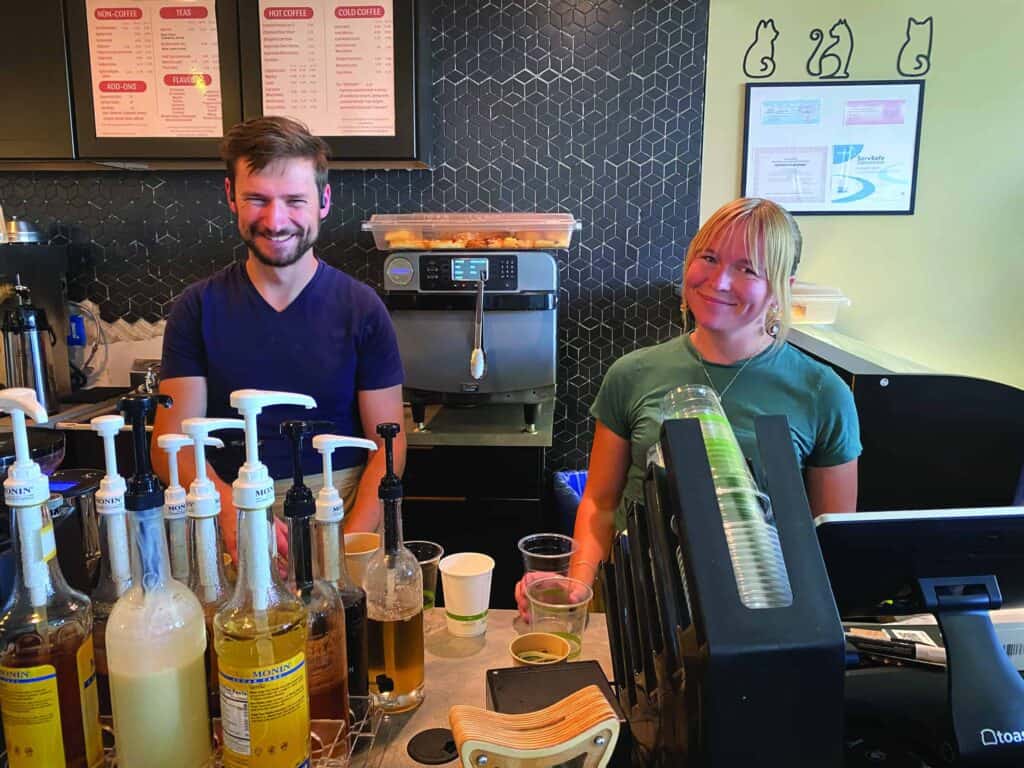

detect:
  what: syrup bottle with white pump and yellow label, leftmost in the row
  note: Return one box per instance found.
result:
[0,388,103,768]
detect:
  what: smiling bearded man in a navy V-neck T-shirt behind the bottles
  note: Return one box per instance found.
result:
[152,118,406,553]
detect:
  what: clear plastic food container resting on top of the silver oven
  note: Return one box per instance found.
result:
[362,213,581,251]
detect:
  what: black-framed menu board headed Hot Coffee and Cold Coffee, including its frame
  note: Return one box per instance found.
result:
[239,0,430,164]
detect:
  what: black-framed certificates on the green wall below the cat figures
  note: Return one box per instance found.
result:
[742,80,925,215]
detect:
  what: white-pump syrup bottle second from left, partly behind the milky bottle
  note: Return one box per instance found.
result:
[89,414,131,715]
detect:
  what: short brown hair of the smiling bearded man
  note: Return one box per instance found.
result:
[220,117,331,201]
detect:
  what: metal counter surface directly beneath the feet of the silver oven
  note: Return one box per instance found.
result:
[404,402,555,447]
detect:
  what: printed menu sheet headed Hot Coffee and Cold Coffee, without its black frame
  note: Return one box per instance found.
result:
[259,0,395,136]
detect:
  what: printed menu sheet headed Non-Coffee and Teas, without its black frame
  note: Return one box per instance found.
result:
[86,0,223,138]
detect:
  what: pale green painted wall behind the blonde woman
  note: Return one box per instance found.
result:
[700,0,1024,387]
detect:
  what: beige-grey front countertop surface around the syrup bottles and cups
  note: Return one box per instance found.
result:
[360,608,611,768]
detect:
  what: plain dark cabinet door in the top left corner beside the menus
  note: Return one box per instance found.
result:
[0,0,75,160]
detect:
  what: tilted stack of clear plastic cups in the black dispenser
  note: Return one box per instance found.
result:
[662,384,793,608]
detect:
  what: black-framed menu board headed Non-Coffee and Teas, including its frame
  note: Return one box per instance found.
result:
[68,0,242,160]
